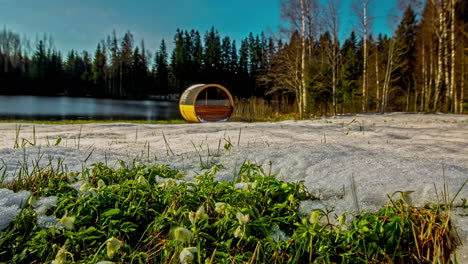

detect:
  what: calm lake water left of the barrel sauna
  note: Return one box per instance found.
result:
[0,95,182,121]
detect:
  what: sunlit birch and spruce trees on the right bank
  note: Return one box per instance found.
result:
[266,0,468,117]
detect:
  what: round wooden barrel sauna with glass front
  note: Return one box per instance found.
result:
[179,84,234,123]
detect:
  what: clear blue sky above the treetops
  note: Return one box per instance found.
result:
[0,0,396,52]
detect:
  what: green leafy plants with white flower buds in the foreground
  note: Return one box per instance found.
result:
[0,163,455,264]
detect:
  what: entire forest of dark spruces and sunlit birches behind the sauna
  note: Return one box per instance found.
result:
[0,0,468,117]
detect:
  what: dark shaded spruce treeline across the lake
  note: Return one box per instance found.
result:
[0,28,274,98]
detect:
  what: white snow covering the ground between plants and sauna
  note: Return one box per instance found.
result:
[0,113,468,263]
